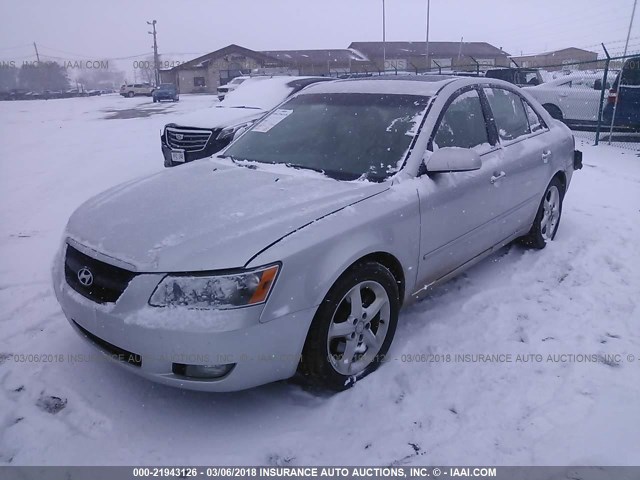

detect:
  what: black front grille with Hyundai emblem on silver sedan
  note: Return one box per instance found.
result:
[64,245,136,303]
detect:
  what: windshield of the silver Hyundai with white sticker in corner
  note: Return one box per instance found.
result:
[225,93,429,181]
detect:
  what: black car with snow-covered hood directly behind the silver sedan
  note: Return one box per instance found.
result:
[160,77,332,167]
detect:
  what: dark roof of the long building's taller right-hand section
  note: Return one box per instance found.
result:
[349,42,508,58]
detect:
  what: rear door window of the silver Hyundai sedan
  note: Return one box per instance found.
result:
[484,88,531,141]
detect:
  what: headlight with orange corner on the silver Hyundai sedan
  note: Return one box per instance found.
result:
[149,265,280,309]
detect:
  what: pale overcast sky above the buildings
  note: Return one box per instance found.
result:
[0,0,640,63]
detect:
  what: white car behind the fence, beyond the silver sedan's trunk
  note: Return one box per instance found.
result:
[527,72,613,125]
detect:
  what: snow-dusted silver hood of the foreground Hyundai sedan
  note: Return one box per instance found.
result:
[67,159,388,272]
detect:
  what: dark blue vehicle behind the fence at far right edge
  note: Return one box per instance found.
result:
[602,57,640,132]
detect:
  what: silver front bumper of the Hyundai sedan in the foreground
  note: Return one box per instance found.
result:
[53,244,315,392]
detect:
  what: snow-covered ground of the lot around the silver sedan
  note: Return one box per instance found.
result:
[0,96,640,465]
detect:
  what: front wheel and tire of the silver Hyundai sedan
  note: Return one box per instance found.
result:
[299,261,400,391]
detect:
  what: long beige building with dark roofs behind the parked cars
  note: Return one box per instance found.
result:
[160,42,509,93]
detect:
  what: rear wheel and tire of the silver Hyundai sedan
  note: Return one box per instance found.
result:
[521,177,564,250]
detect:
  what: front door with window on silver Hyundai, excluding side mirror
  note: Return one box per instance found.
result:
[418,87,507,285]
